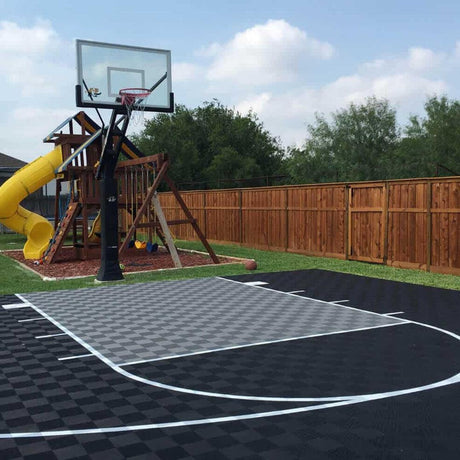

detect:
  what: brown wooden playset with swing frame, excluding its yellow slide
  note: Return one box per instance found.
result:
[41,111,219,267]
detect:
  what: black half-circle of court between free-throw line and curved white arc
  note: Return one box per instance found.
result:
[126,324,460,397]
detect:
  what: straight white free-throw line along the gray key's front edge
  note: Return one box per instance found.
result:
[117,322,406,367]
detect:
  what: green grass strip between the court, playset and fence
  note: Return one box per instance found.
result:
[0,234,460,294]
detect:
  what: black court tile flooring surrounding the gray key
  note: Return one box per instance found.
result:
[0,270,460,460]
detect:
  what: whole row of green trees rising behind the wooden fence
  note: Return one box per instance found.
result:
[134,96,460,189]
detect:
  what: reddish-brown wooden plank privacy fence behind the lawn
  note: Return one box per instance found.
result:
[160,177,460,275]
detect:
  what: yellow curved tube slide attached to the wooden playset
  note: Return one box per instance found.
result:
[0,145,62,259]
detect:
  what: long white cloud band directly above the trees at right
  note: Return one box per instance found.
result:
[236,43,460,145]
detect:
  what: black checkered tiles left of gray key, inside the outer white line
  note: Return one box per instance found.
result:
[0,304,310,432]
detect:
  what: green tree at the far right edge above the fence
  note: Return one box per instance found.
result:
[394,96,460,177]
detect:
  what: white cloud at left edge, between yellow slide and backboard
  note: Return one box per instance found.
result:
[0,20,78,161]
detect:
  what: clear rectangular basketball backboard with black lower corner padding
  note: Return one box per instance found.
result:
[76,40,174,112]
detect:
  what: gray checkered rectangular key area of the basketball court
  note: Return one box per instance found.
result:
[23,278,403,364]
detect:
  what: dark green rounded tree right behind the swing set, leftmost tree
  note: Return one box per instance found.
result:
[133,100,284,188]
